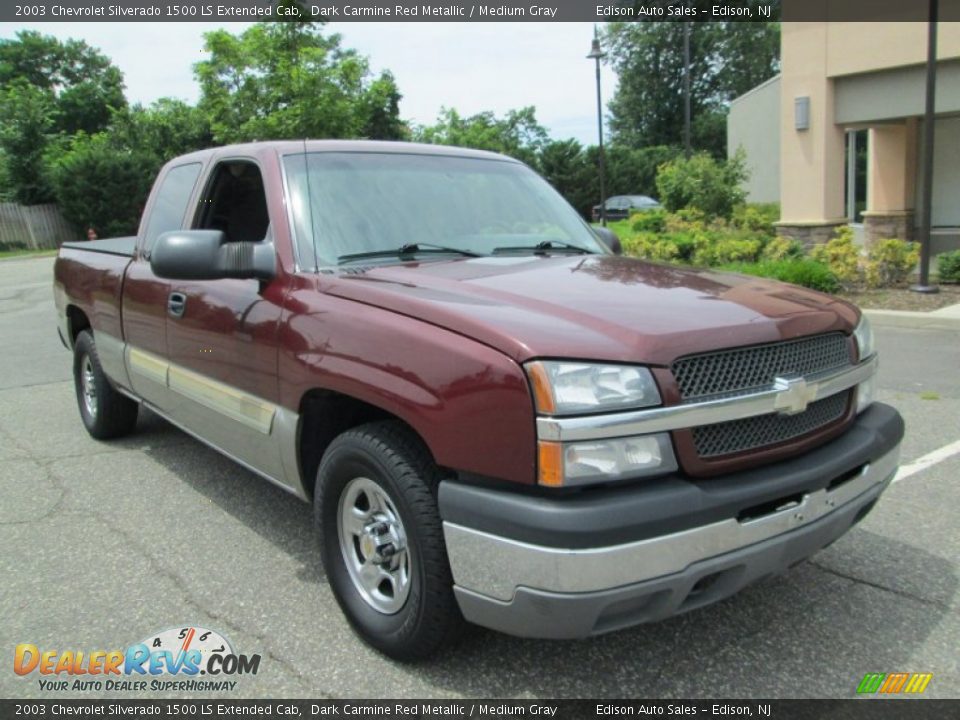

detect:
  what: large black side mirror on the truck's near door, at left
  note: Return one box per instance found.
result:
[150,230,276,280]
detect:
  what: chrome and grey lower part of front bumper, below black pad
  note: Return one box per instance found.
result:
[444,430,902,638]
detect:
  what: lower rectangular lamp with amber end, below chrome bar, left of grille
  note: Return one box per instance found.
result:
[538,433,677,487]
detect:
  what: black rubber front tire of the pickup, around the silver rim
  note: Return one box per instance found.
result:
[314,422,465,661]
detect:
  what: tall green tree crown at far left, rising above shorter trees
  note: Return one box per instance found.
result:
[0,30,126,135]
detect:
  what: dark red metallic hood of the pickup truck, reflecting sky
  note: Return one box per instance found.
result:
[321,255,858,365]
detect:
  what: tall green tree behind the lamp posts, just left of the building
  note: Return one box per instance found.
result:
[604,5,780,157]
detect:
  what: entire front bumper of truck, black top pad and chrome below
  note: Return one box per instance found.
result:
[440,404,903,638]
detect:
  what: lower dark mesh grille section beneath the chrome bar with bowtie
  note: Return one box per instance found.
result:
[693,390,850,458]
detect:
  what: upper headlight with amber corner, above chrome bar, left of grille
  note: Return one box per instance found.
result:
[526,360,660,415]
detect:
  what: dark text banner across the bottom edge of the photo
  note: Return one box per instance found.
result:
[0,698,960,720]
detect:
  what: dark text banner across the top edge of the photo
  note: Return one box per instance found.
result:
[0,0,960,22]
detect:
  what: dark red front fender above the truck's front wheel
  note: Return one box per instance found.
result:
[279,288,536,484]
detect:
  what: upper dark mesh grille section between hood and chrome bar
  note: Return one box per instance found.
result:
[671,333,850,401]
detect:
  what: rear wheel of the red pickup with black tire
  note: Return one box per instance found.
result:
[73,330,140,440]
